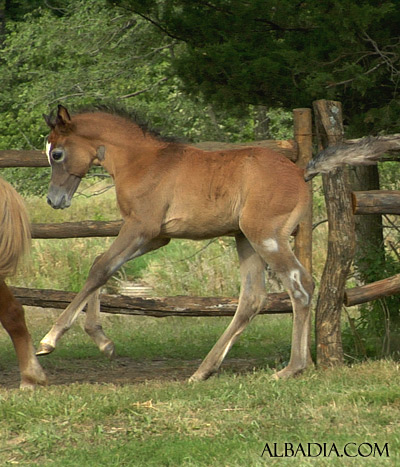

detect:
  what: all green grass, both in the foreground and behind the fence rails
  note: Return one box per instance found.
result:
[0,179,400,467]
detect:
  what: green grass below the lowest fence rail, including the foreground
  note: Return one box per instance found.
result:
[0,310,400,466]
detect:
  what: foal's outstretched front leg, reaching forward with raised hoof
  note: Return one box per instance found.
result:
[36,222,150,355]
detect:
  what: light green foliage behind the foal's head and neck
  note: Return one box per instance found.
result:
[0,0,287,194]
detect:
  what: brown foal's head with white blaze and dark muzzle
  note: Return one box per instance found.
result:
[44,105,104,209]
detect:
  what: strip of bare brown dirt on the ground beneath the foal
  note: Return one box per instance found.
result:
[0,357,257,389]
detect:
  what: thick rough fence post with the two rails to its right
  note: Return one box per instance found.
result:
[313,100,400,366]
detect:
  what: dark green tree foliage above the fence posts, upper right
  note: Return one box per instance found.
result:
[115,0,400,134]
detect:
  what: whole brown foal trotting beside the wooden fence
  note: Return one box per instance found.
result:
[38,106,396,381]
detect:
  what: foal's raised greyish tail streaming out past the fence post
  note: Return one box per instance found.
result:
[304,134,400,182]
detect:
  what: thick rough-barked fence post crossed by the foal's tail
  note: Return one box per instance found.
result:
[313,100,355,367]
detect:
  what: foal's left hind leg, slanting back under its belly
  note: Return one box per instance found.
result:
[189,235,265,381]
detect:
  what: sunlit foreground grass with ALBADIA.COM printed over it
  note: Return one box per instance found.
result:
[0,323,400,466]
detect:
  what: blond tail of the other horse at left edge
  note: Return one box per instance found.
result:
[0,178,31,278]
